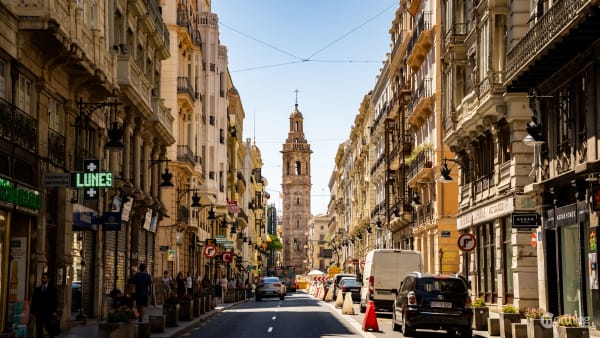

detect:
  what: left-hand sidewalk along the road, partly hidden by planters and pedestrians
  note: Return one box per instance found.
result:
[58,301,245,338]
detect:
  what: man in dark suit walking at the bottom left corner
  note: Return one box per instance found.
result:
[31,272,58,338]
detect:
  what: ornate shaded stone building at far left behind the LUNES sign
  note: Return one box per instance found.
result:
[0,0,175,332]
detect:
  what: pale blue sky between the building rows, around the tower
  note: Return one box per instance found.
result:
[212,0,399,215]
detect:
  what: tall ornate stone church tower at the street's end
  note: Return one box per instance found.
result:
[281,102,312,274]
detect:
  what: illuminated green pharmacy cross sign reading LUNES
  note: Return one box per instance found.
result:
[71,160,113,200]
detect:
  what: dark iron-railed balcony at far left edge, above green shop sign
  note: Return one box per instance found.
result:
[0,98,38,153]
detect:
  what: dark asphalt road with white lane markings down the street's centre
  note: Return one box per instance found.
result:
[180,292,487,338]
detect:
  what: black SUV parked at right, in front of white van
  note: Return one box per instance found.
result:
[392,272,473,338]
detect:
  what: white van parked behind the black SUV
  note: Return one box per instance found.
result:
[360,249,423,313]
